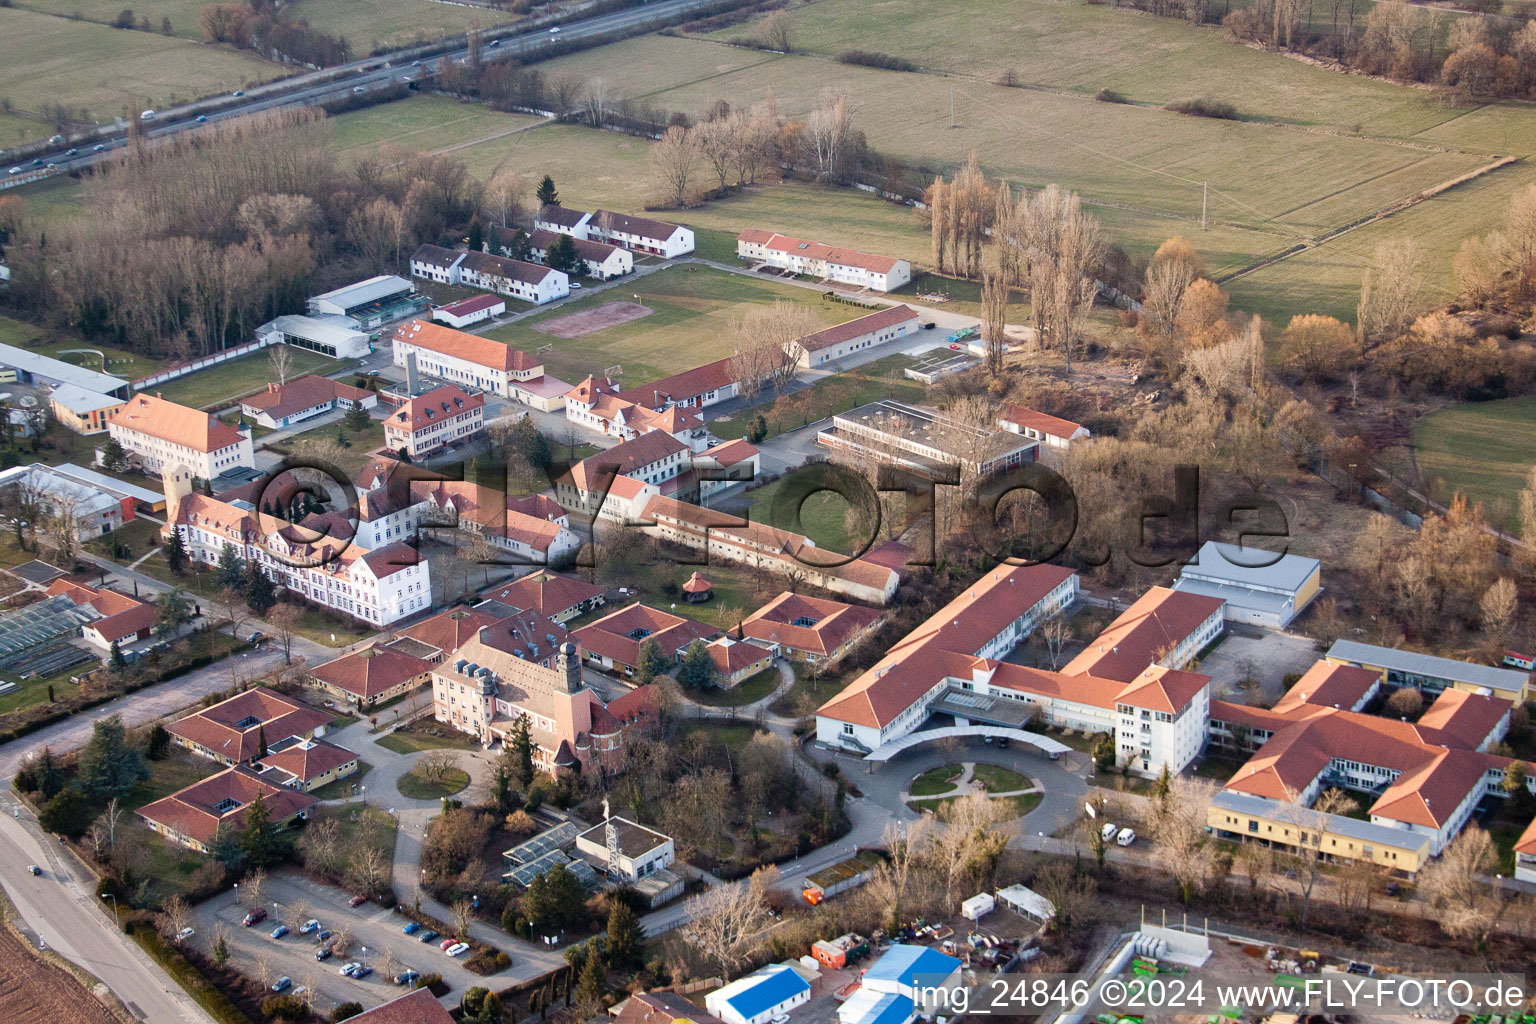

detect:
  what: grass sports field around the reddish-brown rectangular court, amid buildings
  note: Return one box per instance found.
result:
[487,266,863,385]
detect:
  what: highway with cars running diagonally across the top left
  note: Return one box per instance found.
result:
[0,0,717,180]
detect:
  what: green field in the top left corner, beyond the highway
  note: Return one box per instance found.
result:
[0,8,283,141]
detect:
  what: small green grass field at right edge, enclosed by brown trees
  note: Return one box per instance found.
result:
[1413,398,1536,528]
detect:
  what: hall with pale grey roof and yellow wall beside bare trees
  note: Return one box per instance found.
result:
[1174,540,1322,629]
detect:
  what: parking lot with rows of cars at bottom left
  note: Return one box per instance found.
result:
[190,874,495,1012]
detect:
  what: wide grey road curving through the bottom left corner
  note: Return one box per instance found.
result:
[0,798,212,1024]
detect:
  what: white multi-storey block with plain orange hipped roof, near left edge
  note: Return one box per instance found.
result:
[108,393,257,481]
